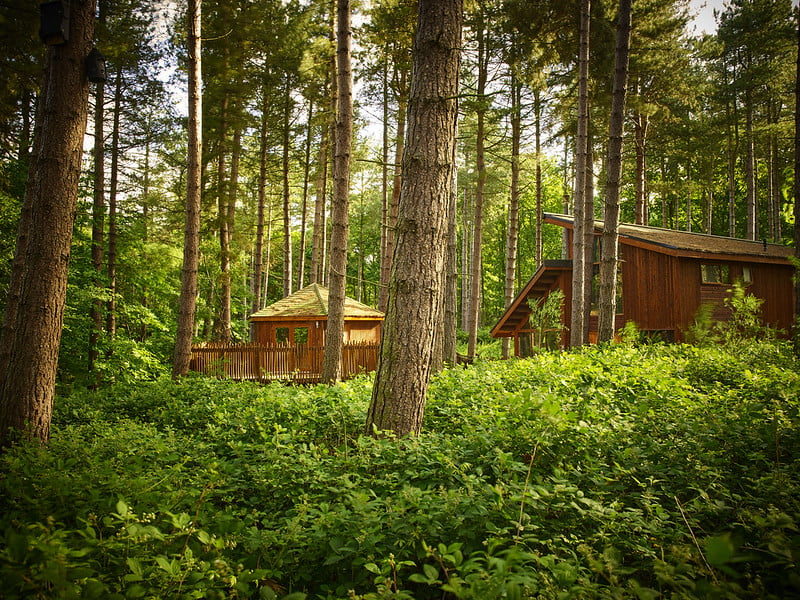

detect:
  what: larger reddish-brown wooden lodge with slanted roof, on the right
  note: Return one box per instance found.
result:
[491,214,795,356]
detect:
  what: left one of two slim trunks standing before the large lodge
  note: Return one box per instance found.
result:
[570,0,591,346]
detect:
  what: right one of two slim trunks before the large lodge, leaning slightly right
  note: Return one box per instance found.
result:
[597,0,631,342]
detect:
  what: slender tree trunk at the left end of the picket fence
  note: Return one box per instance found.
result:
[172,0,203,377]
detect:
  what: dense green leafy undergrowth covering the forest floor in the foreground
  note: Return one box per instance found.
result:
[0,344,800,600]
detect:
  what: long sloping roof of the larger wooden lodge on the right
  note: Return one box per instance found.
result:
[544,213,794,262]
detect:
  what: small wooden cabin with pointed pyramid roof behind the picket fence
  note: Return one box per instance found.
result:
[250,283,384,346]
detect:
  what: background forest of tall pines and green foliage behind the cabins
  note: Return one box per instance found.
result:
[0,0,797,385]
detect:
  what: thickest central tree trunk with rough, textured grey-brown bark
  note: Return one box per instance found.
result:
[366,0,463,436]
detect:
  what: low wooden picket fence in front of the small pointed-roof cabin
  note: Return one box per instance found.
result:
[189,343,380,383]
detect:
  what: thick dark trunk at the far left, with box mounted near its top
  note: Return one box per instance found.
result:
[0,0,95,446]
